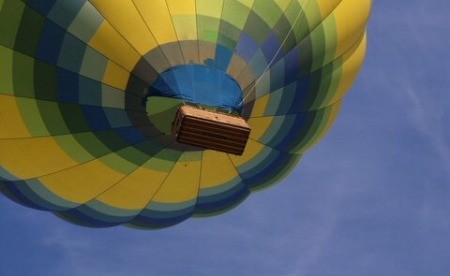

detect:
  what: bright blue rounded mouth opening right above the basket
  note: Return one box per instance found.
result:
[147,64,243,113]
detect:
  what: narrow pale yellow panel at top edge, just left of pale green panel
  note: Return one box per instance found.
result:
[167,0,197,41]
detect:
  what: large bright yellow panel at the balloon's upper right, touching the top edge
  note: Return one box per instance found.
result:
[333,0,371,57]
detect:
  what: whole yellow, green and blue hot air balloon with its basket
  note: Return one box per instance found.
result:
[0,0,371,229]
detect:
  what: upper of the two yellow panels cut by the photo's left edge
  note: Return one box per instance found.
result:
[0,94,31,138]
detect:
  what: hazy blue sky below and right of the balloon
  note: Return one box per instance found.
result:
[0,0,450,276]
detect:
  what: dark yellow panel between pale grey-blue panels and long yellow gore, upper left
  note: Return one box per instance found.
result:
[89,21,140,72]
